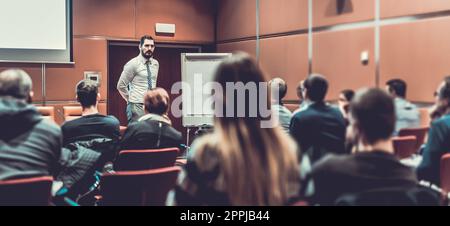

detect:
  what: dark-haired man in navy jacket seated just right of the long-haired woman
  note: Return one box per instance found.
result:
[289,75,345,162]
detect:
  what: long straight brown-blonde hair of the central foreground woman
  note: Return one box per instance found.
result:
[194,54,299,205]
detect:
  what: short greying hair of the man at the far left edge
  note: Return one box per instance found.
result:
[0,69,33,100]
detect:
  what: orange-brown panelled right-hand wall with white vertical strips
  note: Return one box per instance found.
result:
[216,0,450,103]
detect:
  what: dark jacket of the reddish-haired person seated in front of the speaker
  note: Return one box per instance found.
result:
[120,117,183,150]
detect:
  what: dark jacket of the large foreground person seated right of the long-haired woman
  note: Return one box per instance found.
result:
[303,151,418,205]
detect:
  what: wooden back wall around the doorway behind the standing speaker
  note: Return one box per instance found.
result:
[0,0,216,123]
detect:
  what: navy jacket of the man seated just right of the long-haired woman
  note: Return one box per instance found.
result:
[289,102,346,162]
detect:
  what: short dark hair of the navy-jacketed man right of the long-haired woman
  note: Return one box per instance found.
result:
[304,74,328,102]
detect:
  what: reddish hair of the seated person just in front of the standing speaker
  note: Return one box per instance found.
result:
[144,88,170,115]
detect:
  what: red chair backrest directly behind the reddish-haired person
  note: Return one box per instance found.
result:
[114,148,179,171]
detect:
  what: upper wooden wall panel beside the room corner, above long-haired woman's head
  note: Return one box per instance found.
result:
[216,0,256,41]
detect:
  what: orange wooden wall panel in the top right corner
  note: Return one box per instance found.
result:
[380,0,450,18]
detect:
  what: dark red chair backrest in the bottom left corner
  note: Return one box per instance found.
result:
[0,176,53,206]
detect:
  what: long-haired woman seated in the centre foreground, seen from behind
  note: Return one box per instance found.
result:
[174,54,300,206]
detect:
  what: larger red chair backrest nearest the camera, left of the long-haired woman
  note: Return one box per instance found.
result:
[99,166,181,206]
